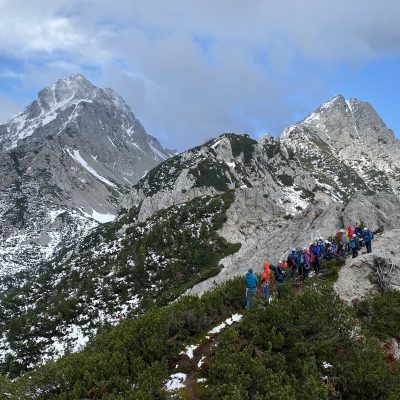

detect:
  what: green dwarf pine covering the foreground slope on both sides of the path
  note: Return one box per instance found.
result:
[0,278,400,400]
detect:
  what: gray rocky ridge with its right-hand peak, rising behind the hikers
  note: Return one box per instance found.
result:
[122,96,400,294]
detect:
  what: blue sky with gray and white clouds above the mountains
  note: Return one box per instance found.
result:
[0,0,400,151]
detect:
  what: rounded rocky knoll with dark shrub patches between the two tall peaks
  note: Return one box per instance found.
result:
[125,134,318,220]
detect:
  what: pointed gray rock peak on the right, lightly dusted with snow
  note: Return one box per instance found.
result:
[281,95,400,200]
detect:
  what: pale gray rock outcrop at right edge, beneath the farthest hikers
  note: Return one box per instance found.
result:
[335,229,400,302]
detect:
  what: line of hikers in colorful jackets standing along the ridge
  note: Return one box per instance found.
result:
[245,223,374,310]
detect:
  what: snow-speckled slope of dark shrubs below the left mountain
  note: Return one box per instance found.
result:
[0,191,240,377]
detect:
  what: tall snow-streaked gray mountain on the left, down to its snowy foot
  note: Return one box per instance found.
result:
[0,74,171,275]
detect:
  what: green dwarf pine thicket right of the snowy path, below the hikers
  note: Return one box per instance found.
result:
[205,280,399,400]
